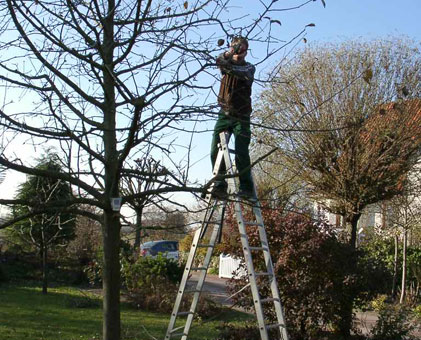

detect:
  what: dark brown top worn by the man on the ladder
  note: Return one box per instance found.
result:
[216,53,256,117]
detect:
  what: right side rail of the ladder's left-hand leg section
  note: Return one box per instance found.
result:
[181,219,223,340]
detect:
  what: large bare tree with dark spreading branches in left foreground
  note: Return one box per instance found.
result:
[0,0,318,340]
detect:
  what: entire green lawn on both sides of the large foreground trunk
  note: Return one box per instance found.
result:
[0,285,250,340]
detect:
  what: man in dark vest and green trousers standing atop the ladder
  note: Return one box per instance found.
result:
[211,36,256,199]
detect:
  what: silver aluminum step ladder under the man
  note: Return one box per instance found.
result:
[165,132,288,340]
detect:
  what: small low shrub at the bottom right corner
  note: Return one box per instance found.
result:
[370,305,414,340]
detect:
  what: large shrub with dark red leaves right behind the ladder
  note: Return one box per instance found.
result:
[222,203,374,340]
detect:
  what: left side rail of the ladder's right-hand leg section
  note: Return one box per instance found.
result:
[220,133,269,340]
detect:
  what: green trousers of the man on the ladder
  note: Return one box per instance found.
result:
[211,111,253,191]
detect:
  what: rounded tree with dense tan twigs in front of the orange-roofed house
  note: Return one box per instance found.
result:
[253,39,421,336]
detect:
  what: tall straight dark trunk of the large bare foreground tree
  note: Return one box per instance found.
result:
[102,0,121,340]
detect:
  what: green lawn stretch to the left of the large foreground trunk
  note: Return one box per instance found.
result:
[0,286,102,340]
